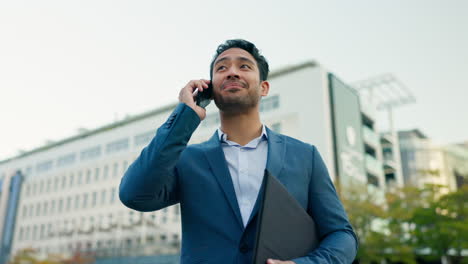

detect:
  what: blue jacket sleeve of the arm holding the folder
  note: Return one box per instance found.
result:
[292,147,358,264]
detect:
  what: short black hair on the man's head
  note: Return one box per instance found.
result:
[210,39,270,81]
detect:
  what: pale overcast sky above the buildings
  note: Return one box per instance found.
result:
[0,0,468,160]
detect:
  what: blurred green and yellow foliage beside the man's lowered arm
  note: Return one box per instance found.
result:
[340,185,468,263]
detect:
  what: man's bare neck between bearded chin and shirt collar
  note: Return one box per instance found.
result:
[220,108,262,146]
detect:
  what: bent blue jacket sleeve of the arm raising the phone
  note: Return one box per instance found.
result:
[119,103,200,212]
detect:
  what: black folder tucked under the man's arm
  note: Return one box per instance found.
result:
[253,170,318,264]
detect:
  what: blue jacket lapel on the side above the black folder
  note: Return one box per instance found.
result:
[247,127,286,225]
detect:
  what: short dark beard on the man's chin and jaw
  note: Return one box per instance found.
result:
[213,89,260,114]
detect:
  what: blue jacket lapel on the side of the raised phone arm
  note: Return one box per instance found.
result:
[205,131,244,228]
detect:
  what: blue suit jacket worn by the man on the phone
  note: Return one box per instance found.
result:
[119,103,357,264]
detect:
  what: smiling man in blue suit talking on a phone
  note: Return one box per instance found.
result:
[119,40,357,264]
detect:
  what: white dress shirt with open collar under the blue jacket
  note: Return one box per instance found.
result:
[218,125,268,227]
